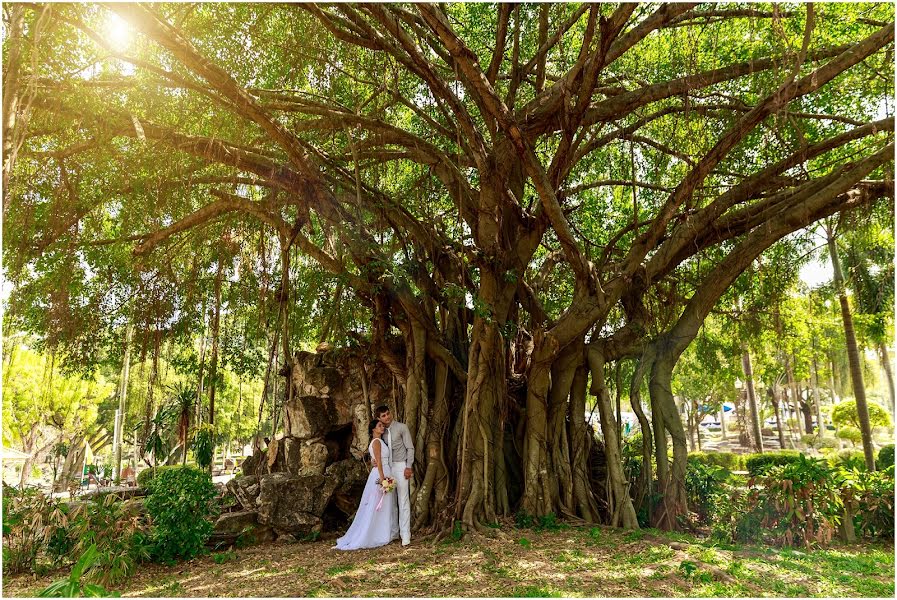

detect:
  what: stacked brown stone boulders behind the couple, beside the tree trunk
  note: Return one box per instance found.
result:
[213,351,394,545]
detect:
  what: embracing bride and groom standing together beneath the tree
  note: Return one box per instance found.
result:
[334,406,414,550]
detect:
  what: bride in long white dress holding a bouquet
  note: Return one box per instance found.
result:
[334,419,399,550]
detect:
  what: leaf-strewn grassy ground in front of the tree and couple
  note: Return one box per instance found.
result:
[3,526,894,598]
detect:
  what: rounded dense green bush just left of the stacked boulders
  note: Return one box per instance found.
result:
[146,467,218,562]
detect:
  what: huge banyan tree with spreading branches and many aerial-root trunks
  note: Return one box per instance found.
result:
[3,3,894,530]
